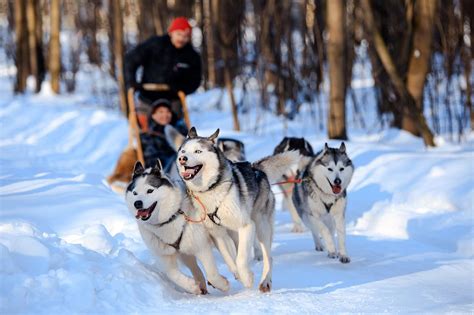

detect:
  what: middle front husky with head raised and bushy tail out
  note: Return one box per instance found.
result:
[176,127,298,292]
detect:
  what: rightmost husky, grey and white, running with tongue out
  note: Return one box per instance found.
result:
[293,142,354,263]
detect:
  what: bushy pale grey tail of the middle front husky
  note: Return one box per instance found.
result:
[252,151,300,184]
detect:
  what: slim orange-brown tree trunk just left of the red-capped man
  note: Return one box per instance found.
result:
[110,0,127,115]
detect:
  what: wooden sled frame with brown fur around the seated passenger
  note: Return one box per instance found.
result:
[107,83,191,193]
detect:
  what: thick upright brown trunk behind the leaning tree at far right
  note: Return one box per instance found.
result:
[402,0,438,135]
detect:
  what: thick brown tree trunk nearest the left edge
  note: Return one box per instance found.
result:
[14,0,29,93]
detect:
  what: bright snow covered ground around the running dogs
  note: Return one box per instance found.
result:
[0,78,474,314]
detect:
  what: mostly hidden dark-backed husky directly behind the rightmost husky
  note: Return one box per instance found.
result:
[273,137,314,233]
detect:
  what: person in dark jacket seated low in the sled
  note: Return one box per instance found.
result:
[140,99,188,170]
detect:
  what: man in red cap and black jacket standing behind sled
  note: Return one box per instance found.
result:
[124,17,201,130]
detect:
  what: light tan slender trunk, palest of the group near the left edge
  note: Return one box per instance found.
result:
[48,0,61,93]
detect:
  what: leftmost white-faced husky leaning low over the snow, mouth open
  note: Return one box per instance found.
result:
[125,161,229,294]
